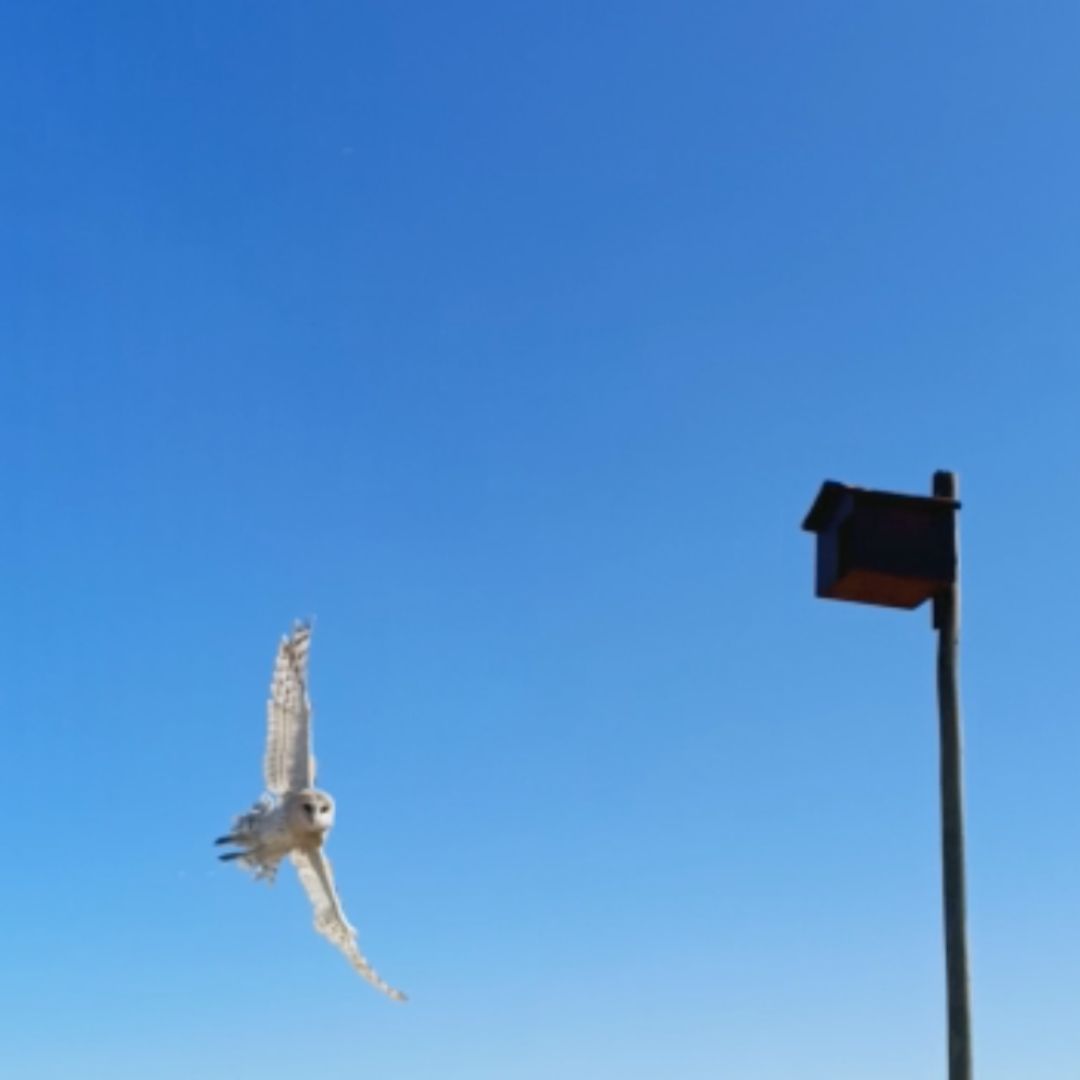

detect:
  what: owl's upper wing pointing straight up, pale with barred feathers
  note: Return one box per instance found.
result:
[262,622,315,795]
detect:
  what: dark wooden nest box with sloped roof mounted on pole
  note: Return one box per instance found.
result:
[802,481,960,608]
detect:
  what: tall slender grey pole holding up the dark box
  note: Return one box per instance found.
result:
[933,472,972,1080]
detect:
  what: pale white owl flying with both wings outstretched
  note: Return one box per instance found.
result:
[215,622,405,1001]
